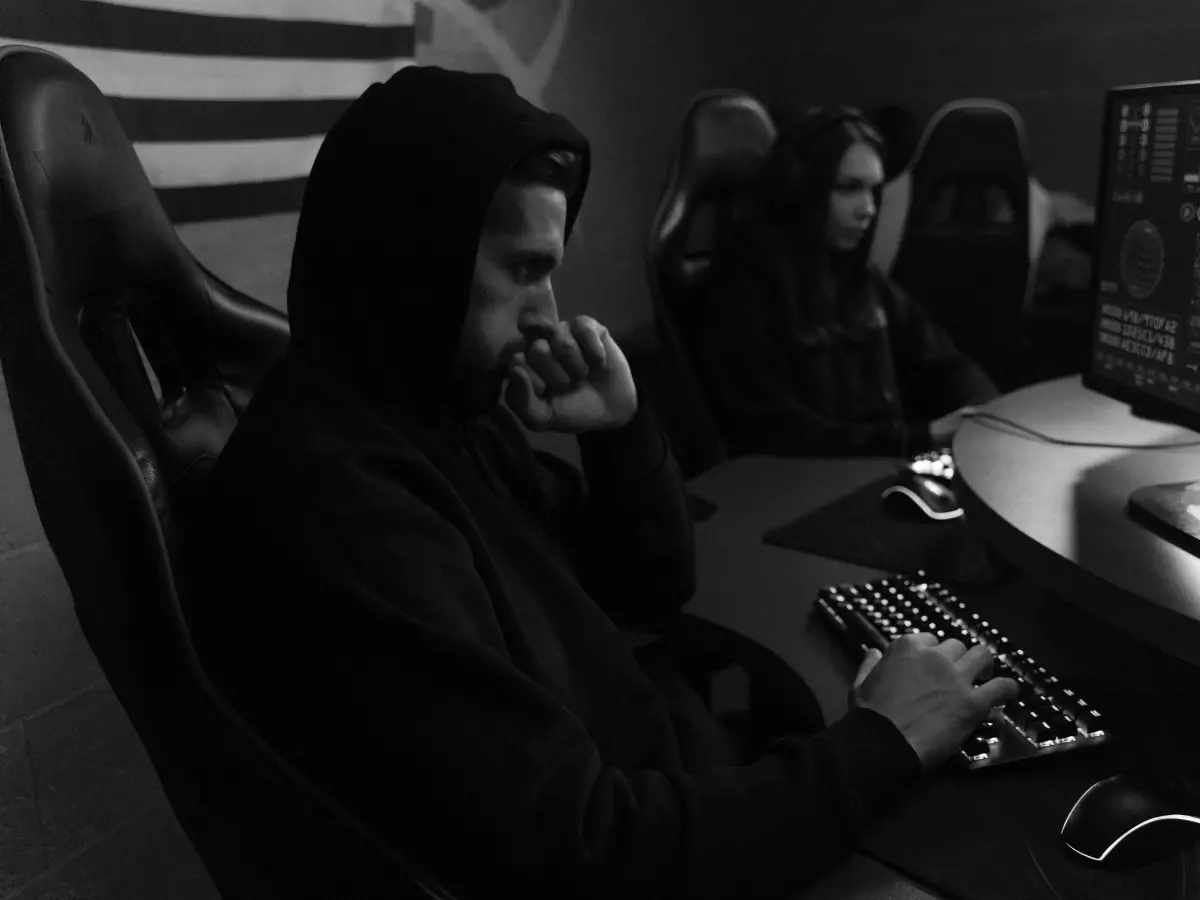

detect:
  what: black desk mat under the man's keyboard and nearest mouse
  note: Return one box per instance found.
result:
[862,575,1200,900]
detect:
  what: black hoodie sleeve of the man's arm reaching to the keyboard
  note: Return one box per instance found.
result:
[246,488,920,900]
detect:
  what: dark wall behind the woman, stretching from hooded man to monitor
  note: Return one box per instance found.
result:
[546,0,1200,329]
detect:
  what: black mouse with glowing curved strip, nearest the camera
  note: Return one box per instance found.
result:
[1061,775,1200,868]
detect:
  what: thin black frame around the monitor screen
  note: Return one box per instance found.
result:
[1082,80,1200,431]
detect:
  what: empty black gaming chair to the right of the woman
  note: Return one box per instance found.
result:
[876,100,1036,390]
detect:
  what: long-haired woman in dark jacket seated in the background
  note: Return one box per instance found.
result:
[696,107,998,456]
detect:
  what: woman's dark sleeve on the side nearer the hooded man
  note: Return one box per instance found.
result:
[698,276,931,456]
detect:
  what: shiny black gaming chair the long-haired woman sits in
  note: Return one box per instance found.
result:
[646,90,776,475]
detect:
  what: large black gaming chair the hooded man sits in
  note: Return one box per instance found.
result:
[0,46,456,900]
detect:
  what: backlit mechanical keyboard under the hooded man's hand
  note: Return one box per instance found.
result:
[814,572,1109,769]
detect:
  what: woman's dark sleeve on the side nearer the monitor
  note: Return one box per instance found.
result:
[880,276,1000,418]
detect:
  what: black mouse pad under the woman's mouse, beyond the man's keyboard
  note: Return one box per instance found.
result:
[763,475,1010,587]
